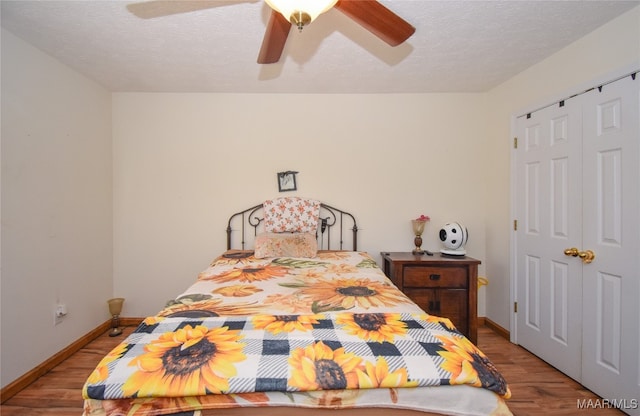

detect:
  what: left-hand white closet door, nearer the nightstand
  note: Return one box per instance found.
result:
[516,99,582,379]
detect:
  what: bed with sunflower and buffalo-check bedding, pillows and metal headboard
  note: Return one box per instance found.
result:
[83,197,511,416]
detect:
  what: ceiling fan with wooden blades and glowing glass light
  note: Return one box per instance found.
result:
[127,0,416,64]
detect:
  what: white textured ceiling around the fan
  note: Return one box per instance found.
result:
[0,0,640,93]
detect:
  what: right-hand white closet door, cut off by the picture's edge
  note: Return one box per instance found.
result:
[581,77,640,404]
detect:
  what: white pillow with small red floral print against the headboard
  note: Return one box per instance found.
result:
[262,197,320,233]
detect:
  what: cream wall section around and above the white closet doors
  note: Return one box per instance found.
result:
[486,7,640,328]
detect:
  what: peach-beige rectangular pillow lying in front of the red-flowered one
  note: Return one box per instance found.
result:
[254,233,318,259]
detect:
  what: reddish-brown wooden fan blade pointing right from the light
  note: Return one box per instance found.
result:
[334,0,416,46]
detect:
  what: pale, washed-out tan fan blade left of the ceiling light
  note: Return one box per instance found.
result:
[127,0,257,19]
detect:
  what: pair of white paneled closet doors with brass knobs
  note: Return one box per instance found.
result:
[514,76,640,414]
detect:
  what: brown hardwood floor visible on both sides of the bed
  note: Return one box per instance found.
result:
[0,327,623,416]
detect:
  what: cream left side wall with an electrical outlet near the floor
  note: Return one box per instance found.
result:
[0,30,113,387]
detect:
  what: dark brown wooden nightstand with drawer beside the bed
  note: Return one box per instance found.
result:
[380,251,480,344]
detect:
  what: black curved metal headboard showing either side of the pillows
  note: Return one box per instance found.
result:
[227,203,358,251]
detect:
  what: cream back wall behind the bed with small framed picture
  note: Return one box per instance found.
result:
[113,93,489,316]
